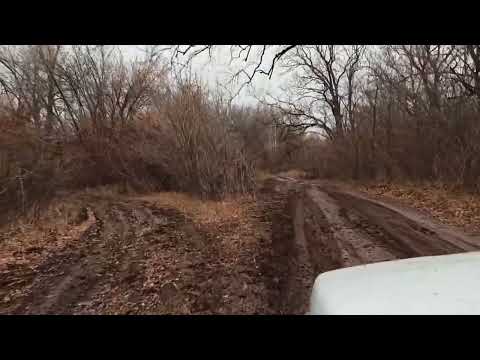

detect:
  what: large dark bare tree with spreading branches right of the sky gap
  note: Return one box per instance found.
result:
[260,45,364,139]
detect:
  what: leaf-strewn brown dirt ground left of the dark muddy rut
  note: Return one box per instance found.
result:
[0,191,273,314]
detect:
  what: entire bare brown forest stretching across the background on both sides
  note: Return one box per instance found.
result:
[0,45,480,219]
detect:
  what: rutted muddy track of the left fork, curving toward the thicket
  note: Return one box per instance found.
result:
[7,199,212,314]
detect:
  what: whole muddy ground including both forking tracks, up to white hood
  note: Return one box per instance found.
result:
[0,177,480,314]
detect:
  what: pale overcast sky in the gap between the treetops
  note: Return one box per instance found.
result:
[120,45,287,105]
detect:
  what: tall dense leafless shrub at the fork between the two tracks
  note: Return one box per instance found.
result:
[152,76,255,197]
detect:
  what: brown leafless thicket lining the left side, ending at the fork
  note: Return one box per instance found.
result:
[0,46,255,219]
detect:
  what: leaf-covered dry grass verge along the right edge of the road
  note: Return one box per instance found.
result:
[361,183,480,232]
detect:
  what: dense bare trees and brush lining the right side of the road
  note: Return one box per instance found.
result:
[268,45,480,189]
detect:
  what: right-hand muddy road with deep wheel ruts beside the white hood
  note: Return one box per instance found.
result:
[271,177,480,313]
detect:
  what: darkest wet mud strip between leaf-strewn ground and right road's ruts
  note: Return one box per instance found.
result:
[258,179,315,314]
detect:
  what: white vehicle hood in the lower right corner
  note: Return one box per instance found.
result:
[309,252,480,315]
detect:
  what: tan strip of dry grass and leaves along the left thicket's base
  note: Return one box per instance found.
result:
[0,186,254,271]
